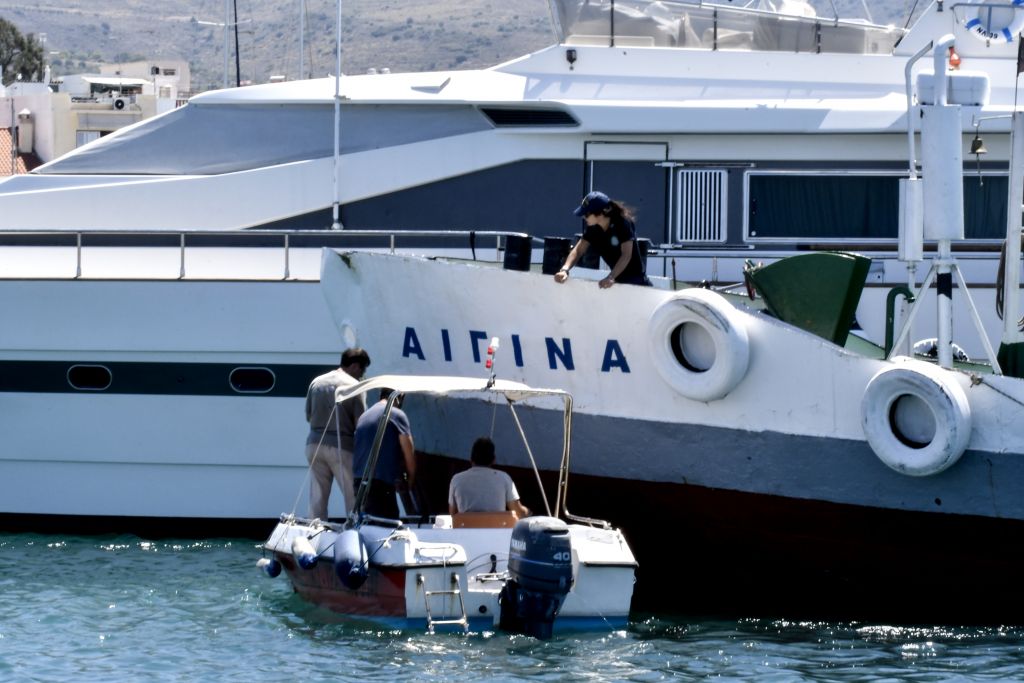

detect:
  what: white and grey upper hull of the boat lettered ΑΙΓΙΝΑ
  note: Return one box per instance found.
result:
[324,252,1024,520]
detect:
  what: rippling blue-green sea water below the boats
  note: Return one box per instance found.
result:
[0,535,1024,682]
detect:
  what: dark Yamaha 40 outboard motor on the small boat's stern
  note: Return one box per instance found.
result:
[499,517,572,638]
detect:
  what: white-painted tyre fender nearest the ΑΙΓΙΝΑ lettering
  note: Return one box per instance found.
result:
[648,289,751,401]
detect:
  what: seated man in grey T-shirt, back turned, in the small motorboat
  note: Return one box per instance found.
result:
[449,436,529,517]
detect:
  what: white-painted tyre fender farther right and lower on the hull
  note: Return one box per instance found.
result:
[860,358,971,476]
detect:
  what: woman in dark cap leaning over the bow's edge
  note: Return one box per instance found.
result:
[555,191,650,289]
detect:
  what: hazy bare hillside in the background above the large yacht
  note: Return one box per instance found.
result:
[0,0,913,91]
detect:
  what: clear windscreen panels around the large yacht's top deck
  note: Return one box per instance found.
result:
[551,0,906,54]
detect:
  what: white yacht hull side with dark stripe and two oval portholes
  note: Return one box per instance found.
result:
[0,250,344,535]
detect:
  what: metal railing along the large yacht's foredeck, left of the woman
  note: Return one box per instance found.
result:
[0,229,544,280]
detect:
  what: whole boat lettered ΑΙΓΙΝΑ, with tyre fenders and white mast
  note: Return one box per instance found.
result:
[322,36,1024,623]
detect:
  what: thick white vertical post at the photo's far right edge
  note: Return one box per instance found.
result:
[1002,112,1024,345]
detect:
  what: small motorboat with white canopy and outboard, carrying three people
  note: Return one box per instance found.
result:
[259,366,637,638]
